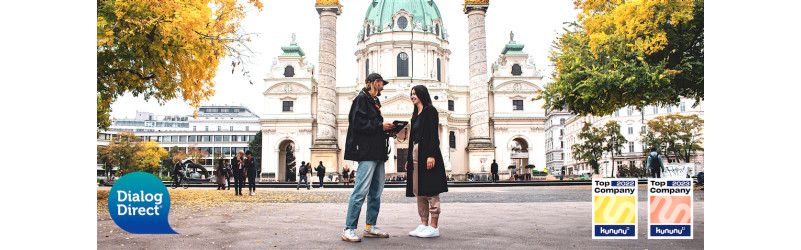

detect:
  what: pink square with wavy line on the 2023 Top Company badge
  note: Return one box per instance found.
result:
[649,196,692,223]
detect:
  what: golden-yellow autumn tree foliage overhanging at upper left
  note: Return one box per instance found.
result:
[97,0,262,130]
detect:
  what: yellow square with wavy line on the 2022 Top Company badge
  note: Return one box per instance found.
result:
[593,196,637,224]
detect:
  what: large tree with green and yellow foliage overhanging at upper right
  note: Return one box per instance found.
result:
[537,0,704,116]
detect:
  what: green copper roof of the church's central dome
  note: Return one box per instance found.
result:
[364,0,442,35]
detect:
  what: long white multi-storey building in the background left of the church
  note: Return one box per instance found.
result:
[97,105,260,174]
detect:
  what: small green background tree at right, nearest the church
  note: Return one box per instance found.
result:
[572,122,605,174]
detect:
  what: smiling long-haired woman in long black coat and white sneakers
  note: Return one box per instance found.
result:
[406,85,448,238]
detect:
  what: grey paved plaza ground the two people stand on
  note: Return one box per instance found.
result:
[97,185,704,249]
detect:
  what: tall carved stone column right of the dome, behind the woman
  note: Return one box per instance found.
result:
[462,1,495,179]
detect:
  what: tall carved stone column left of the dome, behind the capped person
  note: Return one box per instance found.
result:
[310,1,342,171]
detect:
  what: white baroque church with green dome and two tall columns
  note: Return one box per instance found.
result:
[260,0,546,181]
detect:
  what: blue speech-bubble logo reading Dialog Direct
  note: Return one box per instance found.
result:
[108,172,178,234]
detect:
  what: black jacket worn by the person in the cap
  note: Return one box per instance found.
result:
[345,89,389,161]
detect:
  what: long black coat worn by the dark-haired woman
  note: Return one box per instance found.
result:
[406,106,448,197]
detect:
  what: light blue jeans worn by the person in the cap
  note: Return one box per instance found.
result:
[345,161,384,229]
